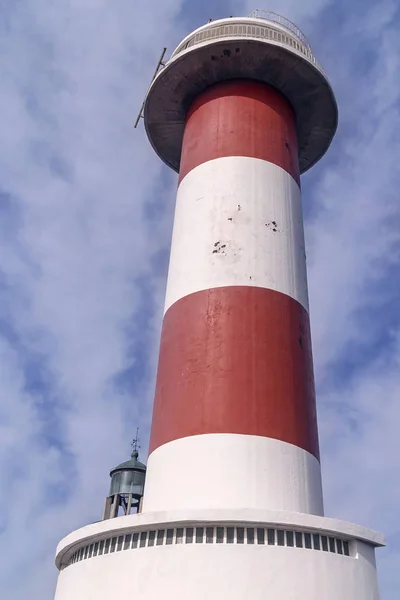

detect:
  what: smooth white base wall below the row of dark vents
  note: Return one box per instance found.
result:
[55,542,379,600]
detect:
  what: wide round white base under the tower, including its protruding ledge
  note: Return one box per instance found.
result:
[55,509,384,600]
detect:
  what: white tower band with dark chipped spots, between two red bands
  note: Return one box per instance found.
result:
[165,156,308,310]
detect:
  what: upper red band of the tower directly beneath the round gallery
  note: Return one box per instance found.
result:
[179,80,300,185]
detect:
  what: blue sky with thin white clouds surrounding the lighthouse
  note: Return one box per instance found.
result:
[0,0,400,600]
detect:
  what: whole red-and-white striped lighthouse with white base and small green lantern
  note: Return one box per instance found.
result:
[52,11,384,600]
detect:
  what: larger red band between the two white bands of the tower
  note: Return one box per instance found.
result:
[150,286,319,458]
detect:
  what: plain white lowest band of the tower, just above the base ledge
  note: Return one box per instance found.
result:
[143,433,323,515]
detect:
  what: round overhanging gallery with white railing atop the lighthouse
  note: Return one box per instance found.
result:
[144,11,338,173]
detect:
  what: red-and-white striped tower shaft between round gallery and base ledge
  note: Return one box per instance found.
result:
[143,80,323,514]
